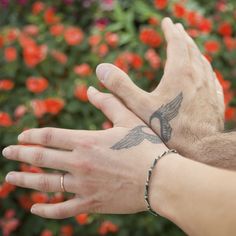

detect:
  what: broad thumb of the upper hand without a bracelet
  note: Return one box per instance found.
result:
[96,63,148,112]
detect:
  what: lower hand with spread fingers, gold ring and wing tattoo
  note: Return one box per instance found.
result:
[3,88,167,219]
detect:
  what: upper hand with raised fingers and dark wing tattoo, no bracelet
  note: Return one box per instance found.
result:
[96,18,224,159]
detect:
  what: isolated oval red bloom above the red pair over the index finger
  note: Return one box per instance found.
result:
[26,77,48,93]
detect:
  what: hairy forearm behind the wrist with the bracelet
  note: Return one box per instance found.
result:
[190,132,236,170]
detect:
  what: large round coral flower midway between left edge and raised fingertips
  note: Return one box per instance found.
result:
[64,26,84,46]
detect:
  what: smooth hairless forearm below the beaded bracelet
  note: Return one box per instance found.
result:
[150,154,236,235]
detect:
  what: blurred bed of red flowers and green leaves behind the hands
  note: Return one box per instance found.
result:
[0,0,236,236]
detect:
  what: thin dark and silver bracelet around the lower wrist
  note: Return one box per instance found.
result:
[144,149,177,216]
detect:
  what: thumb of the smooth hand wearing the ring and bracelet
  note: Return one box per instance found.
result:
[88,87,141,127]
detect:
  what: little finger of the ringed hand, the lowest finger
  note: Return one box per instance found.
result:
[31,198,92,219]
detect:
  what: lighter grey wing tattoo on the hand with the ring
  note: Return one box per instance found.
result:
[111,125,162,150]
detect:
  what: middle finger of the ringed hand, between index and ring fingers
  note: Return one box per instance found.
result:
[3,145,73,171]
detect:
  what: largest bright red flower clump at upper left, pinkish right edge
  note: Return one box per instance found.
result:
[23,42,47,67]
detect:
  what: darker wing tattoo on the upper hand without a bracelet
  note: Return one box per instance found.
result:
[149,92,183,142]
